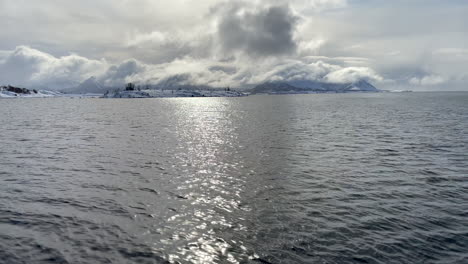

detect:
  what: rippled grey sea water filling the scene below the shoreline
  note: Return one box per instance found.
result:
[0,93,468,264]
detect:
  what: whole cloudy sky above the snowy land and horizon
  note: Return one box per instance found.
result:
[0,0,468,91]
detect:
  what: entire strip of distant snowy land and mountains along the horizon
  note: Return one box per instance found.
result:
[0,77,384,98]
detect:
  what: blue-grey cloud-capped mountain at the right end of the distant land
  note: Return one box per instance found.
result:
[251,80,379,94]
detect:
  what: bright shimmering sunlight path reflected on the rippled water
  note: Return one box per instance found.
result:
[156,98,252,263]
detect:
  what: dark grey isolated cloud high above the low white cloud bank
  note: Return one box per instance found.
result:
[218,5,298,56]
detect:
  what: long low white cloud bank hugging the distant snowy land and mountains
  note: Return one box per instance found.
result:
[0,46,382,89]
